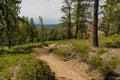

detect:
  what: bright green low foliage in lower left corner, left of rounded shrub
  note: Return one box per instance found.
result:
[0,53,32,80]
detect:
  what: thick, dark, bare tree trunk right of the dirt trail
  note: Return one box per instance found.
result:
[93,0,99,47]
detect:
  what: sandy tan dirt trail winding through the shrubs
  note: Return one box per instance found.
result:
[34,44,90,80]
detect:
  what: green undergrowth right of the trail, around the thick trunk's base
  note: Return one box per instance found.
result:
[52,35,120,80]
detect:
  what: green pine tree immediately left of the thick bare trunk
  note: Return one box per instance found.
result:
[72,0,89,39]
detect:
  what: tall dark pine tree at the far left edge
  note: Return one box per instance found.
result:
[0,0,21,48]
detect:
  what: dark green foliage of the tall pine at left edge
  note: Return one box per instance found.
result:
[0,0,21,48]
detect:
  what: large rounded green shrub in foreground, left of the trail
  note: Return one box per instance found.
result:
[17,59,55,80]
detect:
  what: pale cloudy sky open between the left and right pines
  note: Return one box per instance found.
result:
[19,0,63,24]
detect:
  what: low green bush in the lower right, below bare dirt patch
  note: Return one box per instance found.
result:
[89,55,120,78]
